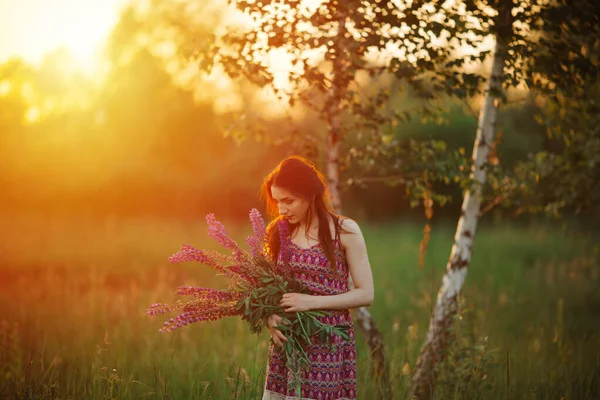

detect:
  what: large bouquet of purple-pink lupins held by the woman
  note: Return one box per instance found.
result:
[147,209,349,393]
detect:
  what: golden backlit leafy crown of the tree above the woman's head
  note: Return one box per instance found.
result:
[139,0,487,169]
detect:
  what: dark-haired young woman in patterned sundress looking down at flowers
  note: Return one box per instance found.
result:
[262,156,373,400]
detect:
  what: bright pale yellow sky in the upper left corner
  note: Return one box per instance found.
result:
[0,0,126,68]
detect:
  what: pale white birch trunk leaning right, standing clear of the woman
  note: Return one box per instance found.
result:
[408,10,512,400]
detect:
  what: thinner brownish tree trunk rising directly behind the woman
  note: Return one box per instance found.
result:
[326,12,390,399]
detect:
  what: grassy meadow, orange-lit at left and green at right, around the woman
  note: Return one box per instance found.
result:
[0,211,600,400]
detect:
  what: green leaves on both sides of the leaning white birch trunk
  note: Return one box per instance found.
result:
[340,0,598,225]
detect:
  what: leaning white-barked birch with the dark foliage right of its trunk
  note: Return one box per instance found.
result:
[409,0,600,399]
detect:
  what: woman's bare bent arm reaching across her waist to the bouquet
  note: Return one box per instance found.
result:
[280,219,374,312]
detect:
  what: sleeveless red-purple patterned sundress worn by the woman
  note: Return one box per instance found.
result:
[262,239,356,400]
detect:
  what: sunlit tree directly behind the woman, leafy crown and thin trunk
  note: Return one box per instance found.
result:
[137,0,492,388]
